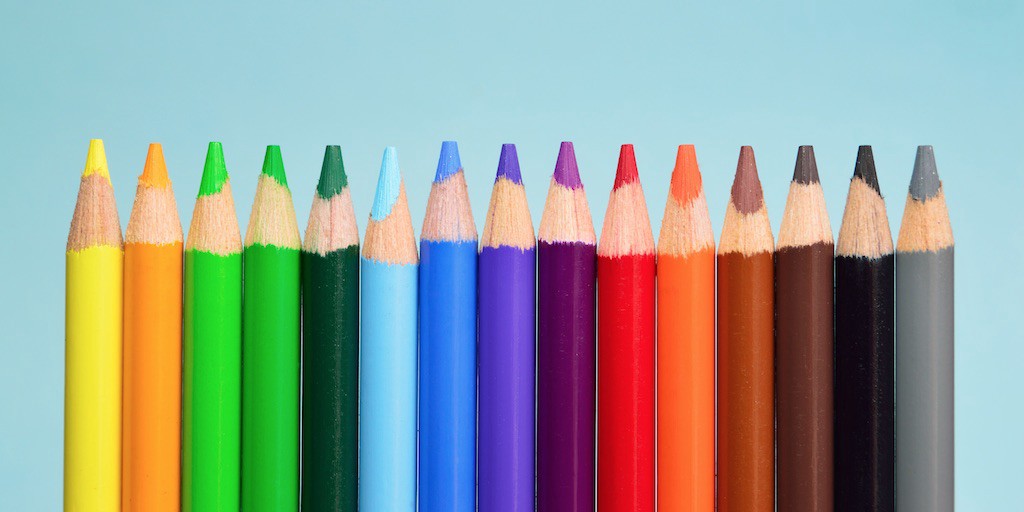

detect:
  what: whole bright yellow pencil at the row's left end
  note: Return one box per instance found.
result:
[63,139,124,512]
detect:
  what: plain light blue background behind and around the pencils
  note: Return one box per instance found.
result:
[0,0,1024,511]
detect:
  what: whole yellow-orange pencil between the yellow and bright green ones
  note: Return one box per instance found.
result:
[121,144,182,512]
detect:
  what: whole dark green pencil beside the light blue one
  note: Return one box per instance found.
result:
[300,145,359,512]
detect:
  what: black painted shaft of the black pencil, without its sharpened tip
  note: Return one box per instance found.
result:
[836,253,896,512]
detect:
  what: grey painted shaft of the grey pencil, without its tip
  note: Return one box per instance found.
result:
[896,247,953,511]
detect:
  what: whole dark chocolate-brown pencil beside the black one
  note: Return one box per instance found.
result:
[775,145,836,511]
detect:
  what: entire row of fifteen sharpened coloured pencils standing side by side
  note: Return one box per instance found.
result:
[65,140,953,512]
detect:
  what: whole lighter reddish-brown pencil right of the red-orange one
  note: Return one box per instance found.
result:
[718,145,775,512]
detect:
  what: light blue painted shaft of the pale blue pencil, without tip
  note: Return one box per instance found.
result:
[359,258,419,512]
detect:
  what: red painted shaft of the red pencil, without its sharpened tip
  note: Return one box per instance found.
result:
[597,254,654,512]
